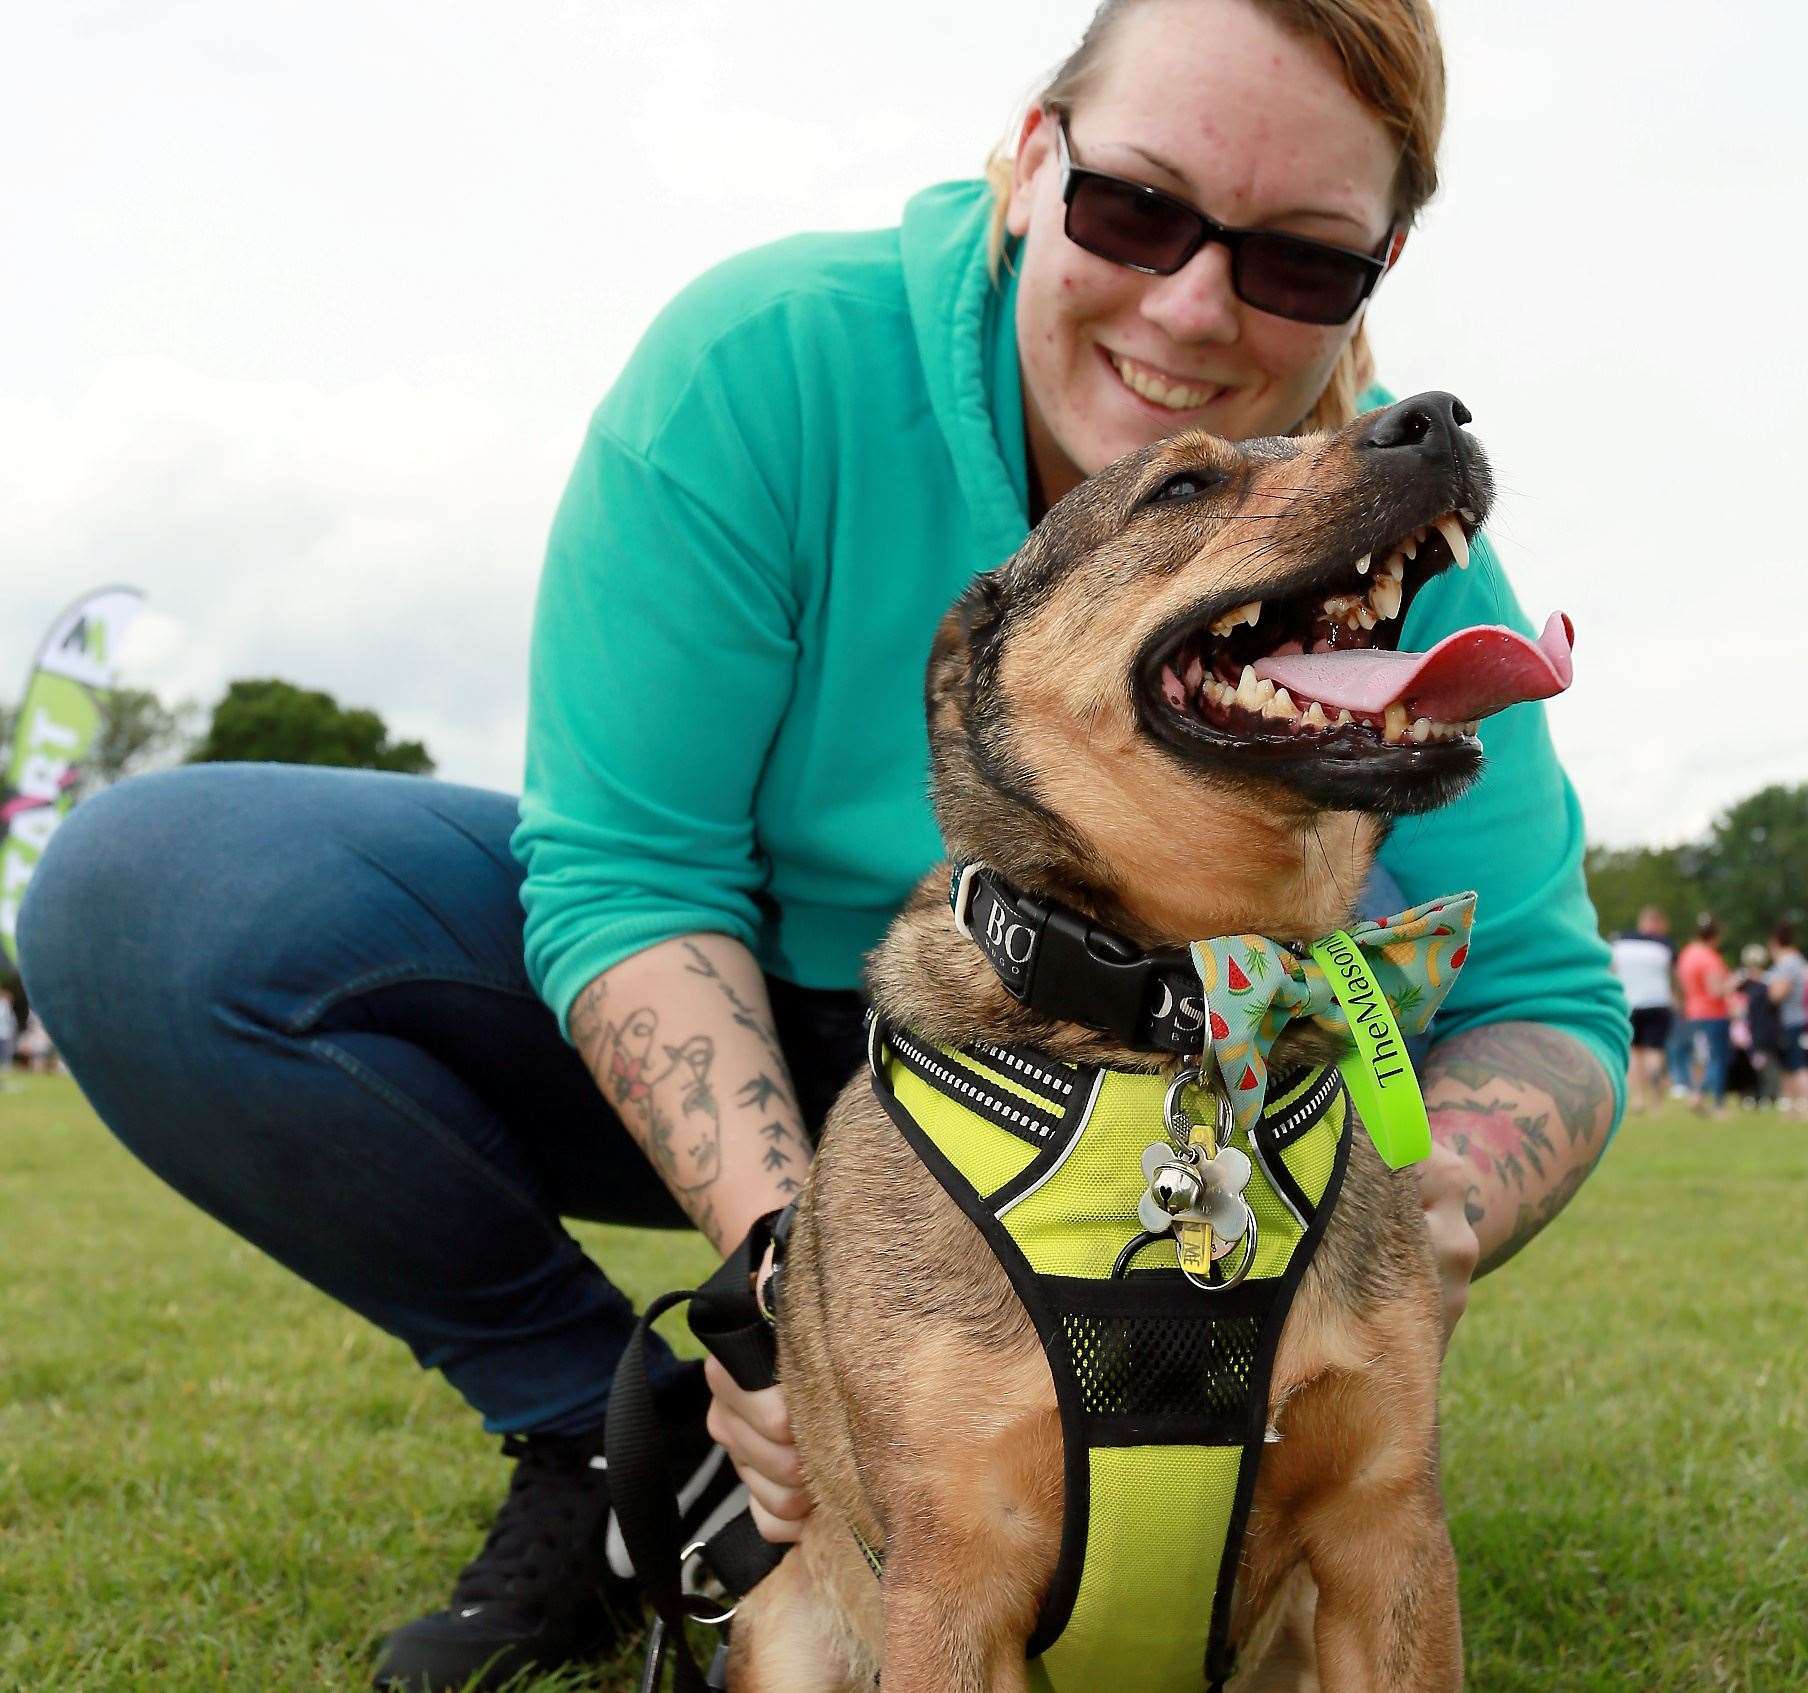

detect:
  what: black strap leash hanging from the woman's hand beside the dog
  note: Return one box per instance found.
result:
[604,1206,792,1693]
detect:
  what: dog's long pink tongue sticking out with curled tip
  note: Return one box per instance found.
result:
[1255,611,1575,724]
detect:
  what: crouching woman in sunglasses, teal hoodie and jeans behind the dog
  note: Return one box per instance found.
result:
[22,0,1625,1686]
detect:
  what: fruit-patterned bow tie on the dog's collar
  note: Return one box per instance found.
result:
[1193,894,1475,1132]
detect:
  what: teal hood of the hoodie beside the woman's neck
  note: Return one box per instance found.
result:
[899,181,1029,564]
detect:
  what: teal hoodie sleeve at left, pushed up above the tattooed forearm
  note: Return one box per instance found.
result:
[512,275,797,1026]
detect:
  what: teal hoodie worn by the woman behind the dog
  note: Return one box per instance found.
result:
[513,183,1629,1114]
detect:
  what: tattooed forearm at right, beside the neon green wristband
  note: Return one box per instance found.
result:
[1419,1022,1613,1331]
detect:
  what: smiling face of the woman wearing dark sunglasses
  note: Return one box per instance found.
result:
[1005,0,1398,503]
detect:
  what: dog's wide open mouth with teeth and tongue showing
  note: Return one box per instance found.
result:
[1137,508,1571,792]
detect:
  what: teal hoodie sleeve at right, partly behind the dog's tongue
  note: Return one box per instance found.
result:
[1381,537,1631,1125]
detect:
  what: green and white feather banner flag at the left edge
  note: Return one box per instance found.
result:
[0,588,145,964]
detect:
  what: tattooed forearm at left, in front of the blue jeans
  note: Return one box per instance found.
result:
[571,933,810,1253]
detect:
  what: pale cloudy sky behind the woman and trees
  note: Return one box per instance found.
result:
[0,0,1808,845]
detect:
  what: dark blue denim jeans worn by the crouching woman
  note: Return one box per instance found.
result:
[18,765,862,1433]
